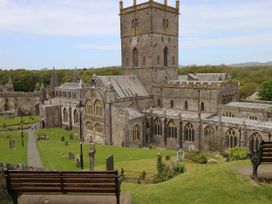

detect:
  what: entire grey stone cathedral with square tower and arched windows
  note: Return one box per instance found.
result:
[40,0,272,151]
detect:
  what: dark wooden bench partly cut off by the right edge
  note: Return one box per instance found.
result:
[250,141,272,179]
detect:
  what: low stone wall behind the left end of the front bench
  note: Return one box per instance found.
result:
[0,163,47,200]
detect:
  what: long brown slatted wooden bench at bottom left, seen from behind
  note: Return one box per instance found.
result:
[5,170,120,204]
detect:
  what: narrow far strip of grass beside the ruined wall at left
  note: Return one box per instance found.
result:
[0,116,40,127]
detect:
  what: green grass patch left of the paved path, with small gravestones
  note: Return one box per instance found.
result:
[0,131,27,164]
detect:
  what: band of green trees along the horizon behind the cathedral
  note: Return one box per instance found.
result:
[0,65,272,100]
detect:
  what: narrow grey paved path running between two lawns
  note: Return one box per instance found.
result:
[27,125,42,167]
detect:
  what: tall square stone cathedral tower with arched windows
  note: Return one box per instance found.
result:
[120,0,180,91]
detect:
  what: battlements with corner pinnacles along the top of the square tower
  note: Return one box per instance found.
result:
[120,0,180,15]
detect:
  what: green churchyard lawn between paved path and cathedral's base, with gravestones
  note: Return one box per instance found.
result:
[36,129,175,170]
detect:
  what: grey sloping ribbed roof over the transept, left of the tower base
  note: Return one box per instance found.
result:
[97,75,149,98]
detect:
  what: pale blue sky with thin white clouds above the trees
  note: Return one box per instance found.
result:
[0,0,272,69]
